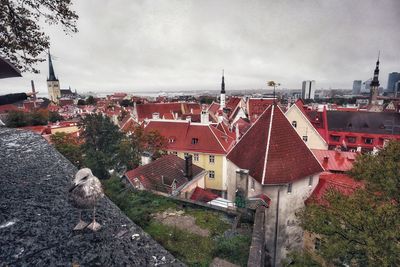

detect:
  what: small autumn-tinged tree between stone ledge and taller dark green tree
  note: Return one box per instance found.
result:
[50,132,83,168]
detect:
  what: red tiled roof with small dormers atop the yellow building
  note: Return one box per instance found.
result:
[145,121,234,154]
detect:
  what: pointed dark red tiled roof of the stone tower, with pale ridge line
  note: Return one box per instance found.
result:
[227,106,323,184]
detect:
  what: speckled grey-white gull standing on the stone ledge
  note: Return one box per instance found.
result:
[69,168,104,231]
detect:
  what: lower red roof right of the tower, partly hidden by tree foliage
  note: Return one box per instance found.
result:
[306,173,364,205]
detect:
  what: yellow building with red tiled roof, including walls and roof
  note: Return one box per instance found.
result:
[145,120,235,196]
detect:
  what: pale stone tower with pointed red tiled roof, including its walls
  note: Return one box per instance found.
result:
[227,105,323,266]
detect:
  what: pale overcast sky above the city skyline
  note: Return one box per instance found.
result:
[0,0,400,93]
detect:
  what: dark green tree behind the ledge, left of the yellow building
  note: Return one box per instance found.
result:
[81,114,122,178]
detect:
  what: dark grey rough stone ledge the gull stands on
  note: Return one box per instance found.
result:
[0,127,182,266]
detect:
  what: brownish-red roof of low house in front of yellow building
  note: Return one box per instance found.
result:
[125,155,204,193]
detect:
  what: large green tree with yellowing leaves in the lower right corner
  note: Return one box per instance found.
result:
[299,141,400,266]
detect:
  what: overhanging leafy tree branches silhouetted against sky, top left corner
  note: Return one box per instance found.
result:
[0,0,78,72]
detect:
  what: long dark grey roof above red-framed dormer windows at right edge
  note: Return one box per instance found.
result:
[327,111,400,134]
